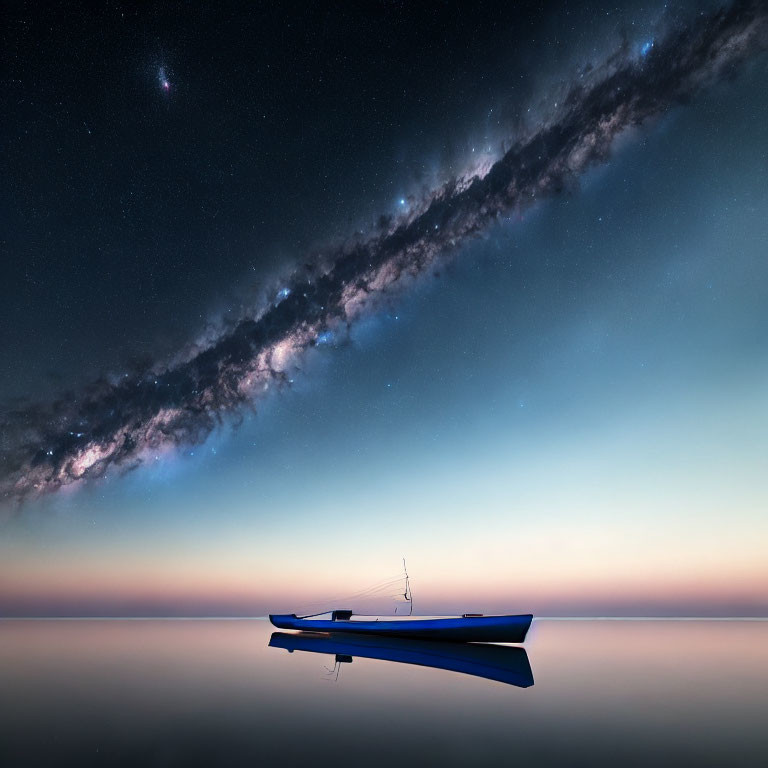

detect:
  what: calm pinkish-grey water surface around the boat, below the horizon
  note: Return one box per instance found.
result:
[0,620,768,768]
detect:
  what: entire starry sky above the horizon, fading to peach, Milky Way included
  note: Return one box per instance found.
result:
[0,0,768,615]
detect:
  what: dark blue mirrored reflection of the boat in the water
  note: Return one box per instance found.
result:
[269,632,533,688]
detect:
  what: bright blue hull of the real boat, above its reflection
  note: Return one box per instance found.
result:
[269,613,533,643]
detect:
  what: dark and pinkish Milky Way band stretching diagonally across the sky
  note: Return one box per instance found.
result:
[0,1,768,501]
